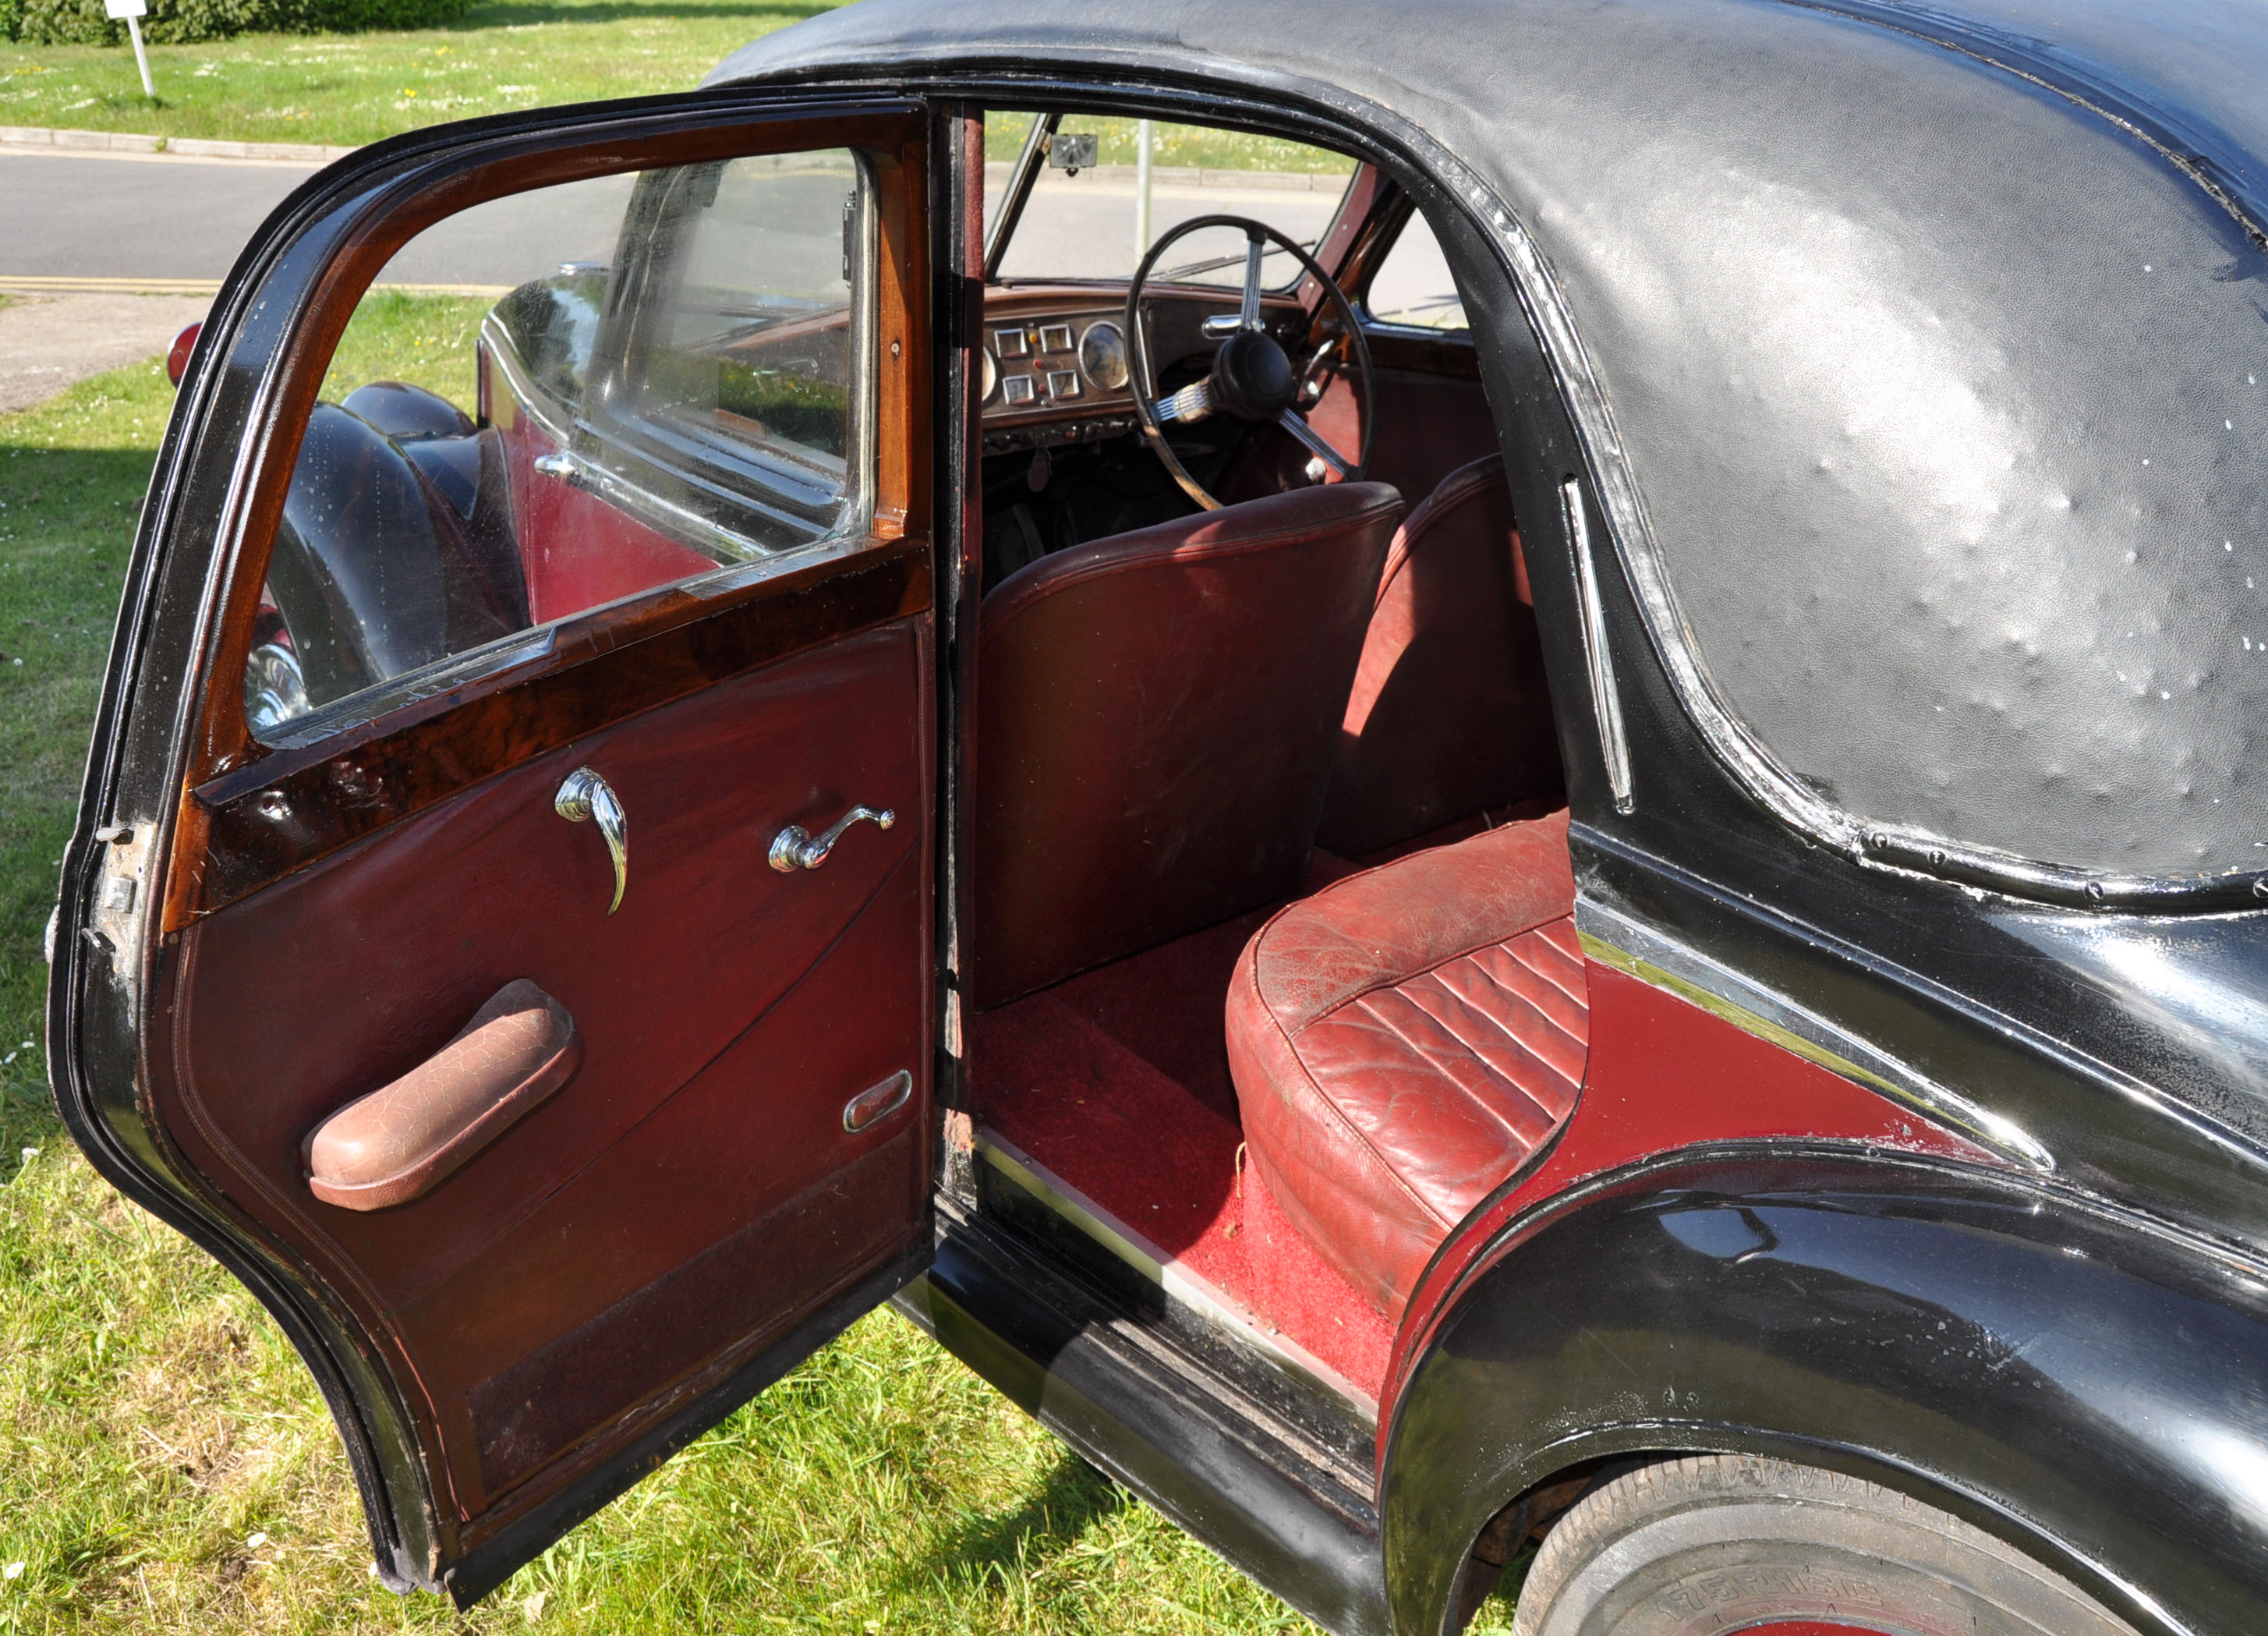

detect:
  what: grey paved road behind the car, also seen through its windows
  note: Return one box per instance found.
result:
[0,150,1449,310]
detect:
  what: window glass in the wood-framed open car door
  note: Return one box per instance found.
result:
[245,150,873,744]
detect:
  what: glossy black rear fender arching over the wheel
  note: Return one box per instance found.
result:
[1379,1146,2268,1636]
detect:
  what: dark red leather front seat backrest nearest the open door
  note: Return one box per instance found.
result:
[971,483,1402,1007]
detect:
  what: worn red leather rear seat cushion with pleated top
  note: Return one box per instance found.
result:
[1227,813,1590,1319]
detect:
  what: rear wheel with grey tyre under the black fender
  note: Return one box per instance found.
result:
[1513,1454,2134,1636]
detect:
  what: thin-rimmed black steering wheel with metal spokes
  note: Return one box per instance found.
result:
[1127,215,1377,511]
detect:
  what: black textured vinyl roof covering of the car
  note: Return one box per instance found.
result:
[714,0,2268,887]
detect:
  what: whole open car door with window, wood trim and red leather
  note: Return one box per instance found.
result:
[48,93,936,1604]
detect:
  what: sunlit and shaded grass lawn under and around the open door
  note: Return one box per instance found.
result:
[0,295,1542,1636]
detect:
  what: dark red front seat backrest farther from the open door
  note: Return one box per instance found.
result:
[1315,454,1560,858]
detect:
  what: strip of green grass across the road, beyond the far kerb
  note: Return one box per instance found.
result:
[0,0,833,147]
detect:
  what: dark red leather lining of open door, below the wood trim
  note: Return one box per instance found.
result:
[154,615,932,1536]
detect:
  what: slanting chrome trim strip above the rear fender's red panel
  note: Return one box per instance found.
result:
[1574,896,2055,1173]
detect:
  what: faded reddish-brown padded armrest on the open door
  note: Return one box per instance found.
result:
[306,978,583,1209]
